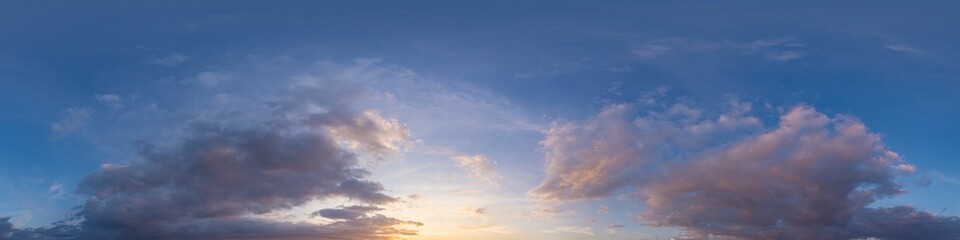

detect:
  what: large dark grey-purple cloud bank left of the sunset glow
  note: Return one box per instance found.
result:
[9,61,421,239]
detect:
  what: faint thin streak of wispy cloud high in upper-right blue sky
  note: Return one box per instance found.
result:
[631,37,806,62]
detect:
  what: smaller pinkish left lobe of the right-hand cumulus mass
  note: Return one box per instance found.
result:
[531,102,759,200]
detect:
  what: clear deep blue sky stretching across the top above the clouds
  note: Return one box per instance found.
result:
[0,1,960,232]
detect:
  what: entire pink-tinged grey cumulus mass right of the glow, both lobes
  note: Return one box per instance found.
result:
[530,97,960,239]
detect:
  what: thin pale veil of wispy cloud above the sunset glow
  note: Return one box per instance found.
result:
[344,59,542,133]
